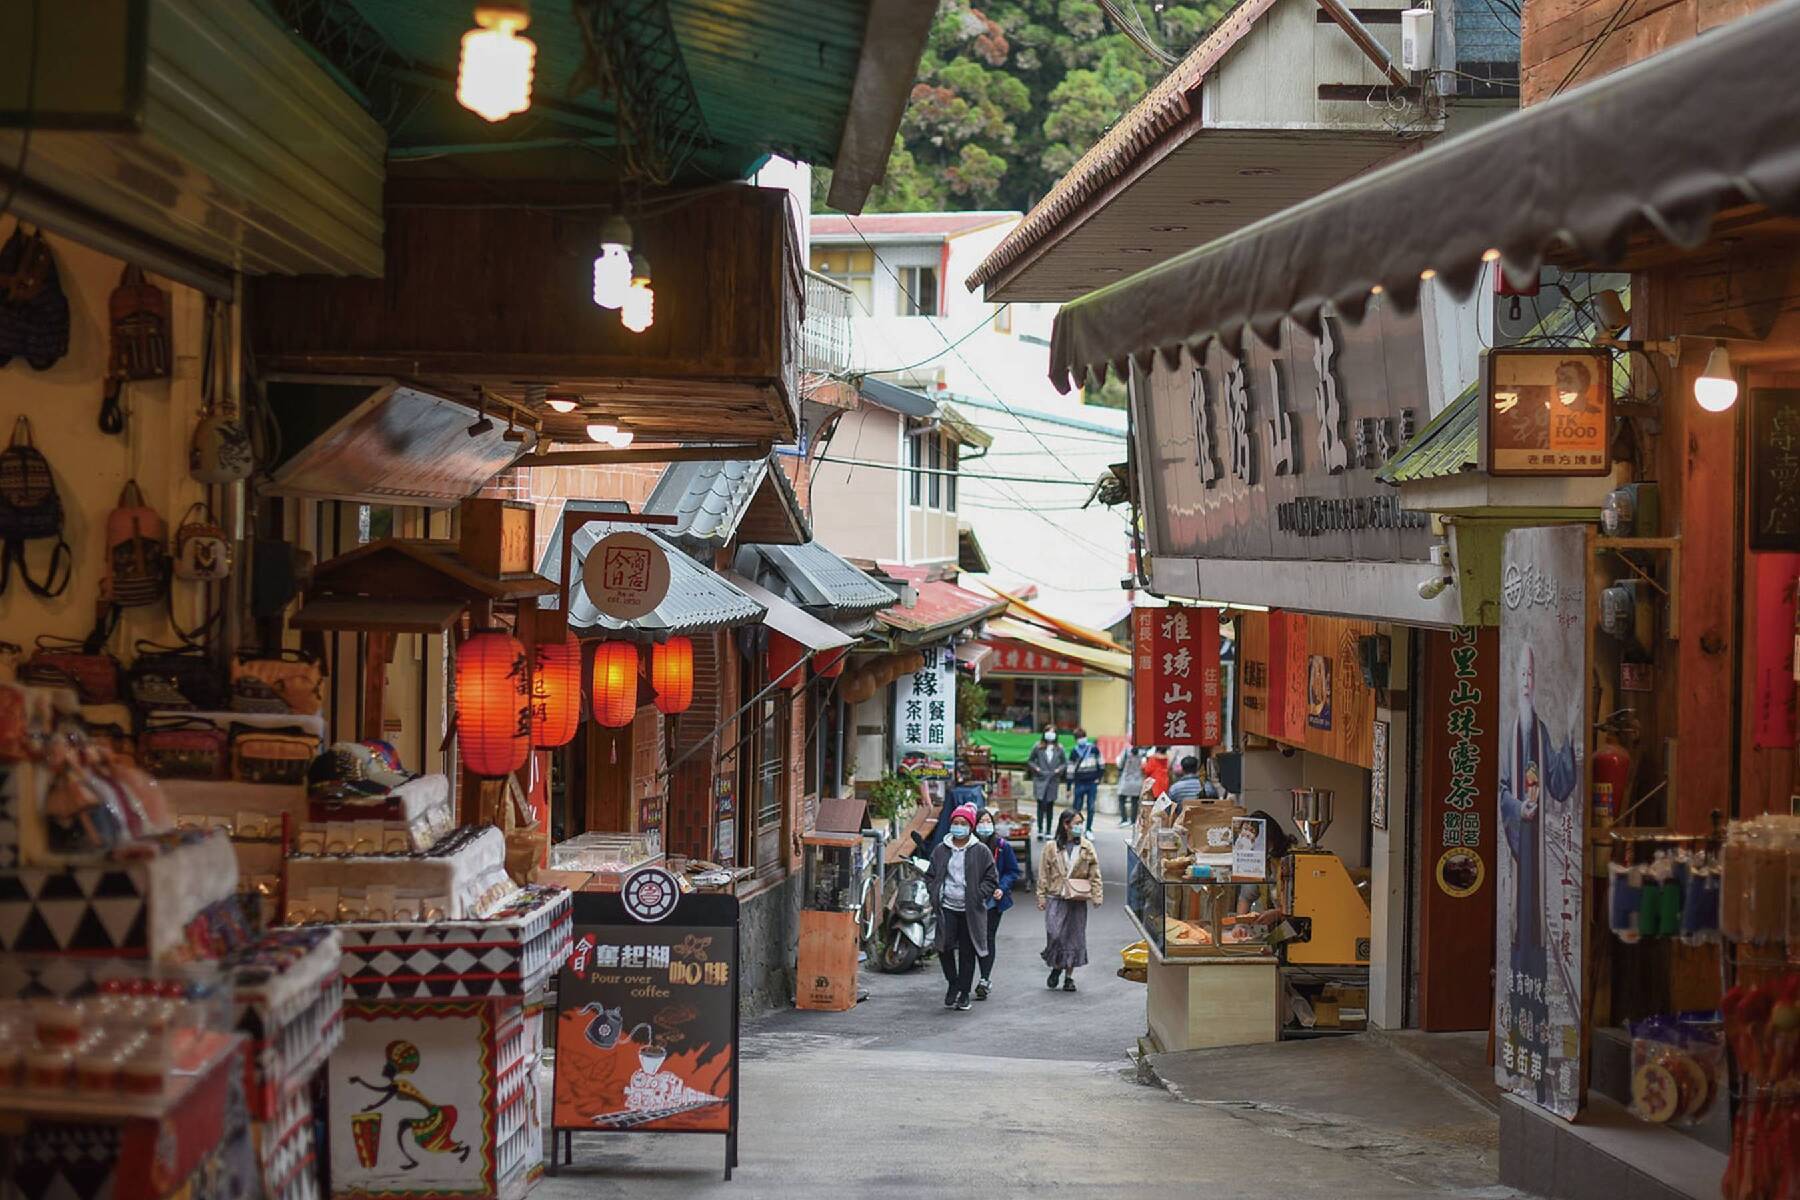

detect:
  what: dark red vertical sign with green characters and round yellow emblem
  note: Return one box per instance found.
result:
[1418,626,1510,1033]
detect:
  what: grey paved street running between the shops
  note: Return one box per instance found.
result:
[536,827,1501,1200]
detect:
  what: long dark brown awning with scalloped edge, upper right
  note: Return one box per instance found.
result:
[1049,0,1800,392]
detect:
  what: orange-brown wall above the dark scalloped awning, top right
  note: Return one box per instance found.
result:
[1519,0,1769,104]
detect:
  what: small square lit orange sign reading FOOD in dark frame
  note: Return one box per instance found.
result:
[1485,347,1613,475]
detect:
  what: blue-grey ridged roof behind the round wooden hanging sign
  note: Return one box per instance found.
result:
[538,518,763,642]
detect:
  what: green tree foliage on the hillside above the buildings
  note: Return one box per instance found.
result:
[815,0,1233,212]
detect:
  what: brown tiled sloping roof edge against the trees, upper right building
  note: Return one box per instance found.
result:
[967,0,1274,291]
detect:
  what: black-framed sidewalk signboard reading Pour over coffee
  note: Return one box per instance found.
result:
[553,888,738,1178]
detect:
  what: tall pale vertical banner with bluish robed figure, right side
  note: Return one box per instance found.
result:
[1490,525,1589,1119]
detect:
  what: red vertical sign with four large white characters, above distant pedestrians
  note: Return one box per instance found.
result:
[1132,608,1224,747]
